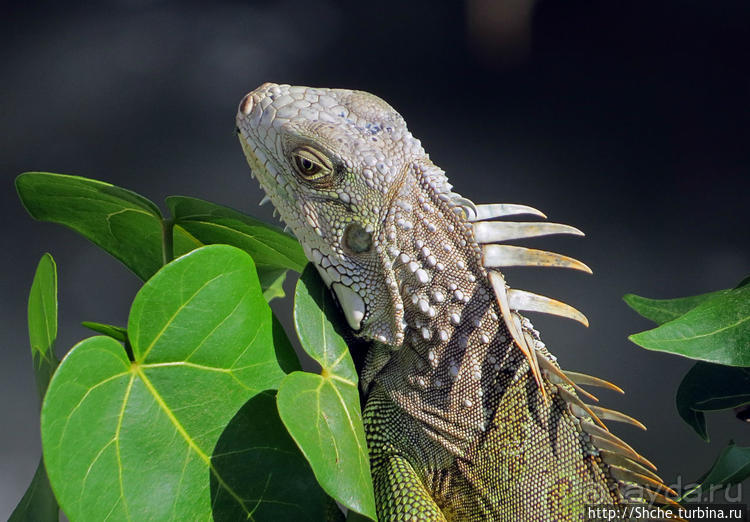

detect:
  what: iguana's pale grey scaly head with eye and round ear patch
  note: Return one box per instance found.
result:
[237,83,434,345]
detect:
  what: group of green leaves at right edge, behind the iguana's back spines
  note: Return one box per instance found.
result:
[624,277,750,500]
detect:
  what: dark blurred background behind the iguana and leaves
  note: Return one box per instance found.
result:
[0,0,750,518]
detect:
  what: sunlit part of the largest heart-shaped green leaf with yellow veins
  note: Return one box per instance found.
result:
[42,245,300,520]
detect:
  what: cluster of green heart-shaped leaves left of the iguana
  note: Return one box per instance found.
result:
[12,172,382,521]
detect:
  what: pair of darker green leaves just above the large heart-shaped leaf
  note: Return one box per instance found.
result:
[16,172,307,300]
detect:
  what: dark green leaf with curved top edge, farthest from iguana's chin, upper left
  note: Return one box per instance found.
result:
[16,172,163,281]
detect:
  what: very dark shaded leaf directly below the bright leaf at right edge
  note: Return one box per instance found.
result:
[675,362,750,441]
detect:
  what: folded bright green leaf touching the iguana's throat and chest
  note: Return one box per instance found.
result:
[277,266,376,520]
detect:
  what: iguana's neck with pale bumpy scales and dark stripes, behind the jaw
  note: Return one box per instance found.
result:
[362,160,523,454]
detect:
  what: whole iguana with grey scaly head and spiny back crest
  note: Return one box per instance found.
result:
[236,83,673,521]
